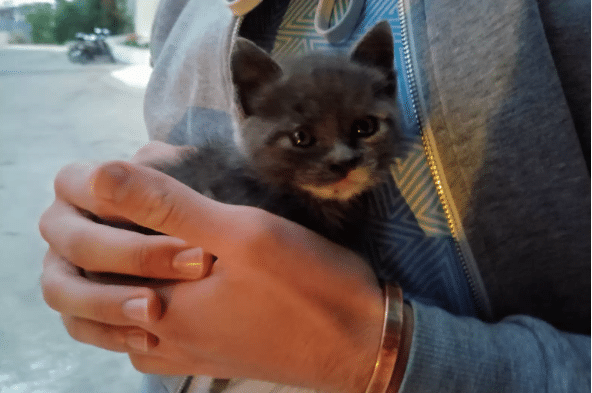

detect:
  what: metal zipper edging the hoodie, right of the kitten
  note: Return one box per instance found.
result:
[397,0,492,319]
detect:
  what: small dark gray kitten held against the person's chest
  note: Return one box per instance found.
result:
[150,22,403,248]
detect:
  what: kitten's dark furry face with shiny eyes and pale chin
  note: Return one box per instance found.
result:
[234,20,401,201]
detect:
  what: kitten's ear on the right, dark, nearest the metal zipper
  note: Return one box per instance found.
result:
[350,20,396,95]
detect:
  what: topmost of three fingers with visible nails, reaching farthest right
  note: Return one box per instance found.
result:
[39,201,212,279]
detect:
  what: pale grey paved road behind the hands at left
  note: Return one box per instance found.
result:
[0,47,147,393]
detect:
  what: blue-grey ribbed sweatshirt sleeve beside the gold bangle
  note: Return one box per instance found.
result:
[400,302,590,393]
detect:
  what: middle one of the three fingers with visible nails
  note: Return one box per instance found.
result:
[41,249,161,326]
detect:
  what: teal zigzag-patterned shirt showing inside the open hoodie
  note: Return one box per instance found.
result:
[241,0,476,316]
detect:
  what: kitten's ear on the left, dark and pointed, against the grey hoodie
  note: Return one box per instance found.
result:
[230,37,282,116]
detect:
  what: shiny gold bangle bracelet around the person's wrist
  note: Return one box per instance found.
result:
[366,284,403,393]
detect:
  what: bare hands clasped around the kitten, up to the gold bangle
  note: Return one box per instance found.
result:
[40,155,384,392]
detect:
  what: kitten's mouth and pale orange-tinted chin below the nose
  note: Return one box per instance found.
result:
[300,168,374,201]
